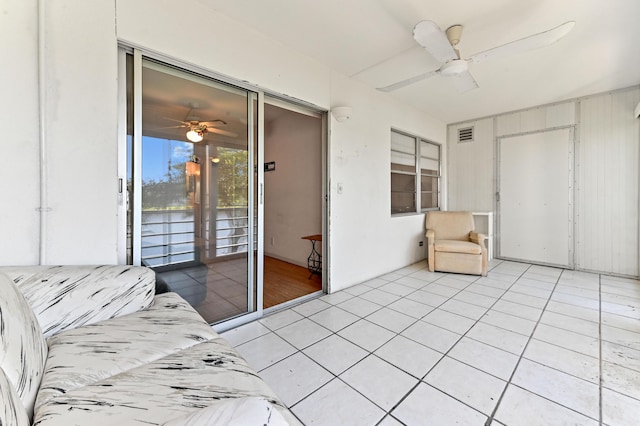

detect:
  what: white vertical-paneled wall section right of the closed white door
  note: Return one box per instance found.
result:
[576,89,640,276]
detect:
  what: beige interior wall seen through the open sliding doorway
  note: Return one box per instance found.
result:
[264,112,322,267]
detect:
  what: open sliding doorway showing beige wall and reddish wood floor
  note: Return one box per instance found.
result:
[263,97,324,309]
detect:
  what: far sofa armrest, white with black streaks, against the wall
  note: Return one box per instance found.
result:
[0,265,155,337]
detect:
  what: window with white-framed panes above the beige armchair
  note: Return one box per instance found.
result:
[391,130,440,215]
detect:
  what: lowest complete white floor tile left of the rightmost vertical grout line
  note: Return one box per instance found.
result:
[512,359,599,419]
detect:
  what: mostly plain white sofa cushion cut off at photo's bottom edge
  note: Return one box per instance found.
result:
[162,397,289,426]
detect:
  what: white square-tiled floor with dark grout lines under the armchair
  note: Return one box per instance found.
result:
[223,261,640,426]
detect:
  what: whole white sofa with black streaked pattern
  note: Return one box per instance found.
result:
[0,266,299,426]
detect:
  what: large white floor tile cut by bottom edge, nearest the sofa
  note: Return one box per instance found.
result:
[291,379,386,426]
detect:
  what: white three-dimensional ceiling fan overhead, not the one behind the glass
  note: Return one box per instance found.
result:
[378,21,575,93]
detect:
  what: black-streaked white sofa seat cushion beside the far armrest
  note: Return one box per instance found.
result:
[36,293,219,411]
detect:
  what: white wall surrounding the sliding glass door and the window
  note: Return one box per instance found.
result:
[0,0,446,290]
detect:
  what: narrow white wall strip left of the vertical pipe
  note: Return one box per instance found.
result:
[0,0,39,265]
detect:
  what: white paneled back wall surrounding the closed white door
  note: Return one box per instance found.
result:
[447,87,640,277]
